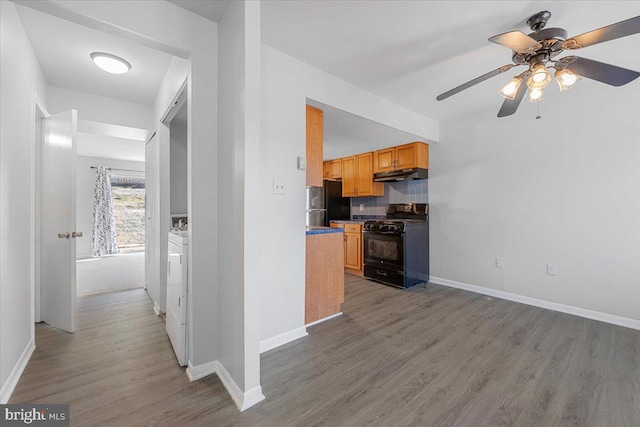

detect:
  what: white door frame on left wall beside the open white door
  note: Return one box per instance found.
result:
[29,91,50,324]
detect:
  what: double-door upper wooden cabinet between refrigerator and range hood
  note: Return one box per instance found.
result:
[342,153,384,197]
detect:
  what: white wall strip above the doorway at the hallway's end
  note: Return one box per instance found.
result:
[47,86,153,129]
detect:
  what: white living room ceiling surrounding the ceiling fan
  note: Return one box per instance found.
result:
[261,0,640,120]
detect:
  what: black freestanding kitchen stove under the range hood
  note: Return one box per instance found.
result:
[363,203,429,288]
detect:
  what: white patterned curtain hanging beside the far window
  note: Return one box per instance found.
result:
[91,166,119,256]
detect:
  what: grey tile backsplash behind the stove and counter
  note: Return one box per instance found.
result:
[351,179,429,217]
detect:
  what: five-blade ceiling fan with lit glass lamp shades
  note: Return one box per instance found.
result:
[436,11,640,117]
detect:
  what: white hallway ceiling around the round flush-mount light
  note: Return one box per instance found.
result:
[15,4,172,105]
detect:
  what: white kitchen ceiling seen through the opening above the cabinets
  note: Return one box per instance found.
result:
[307,99,426,160]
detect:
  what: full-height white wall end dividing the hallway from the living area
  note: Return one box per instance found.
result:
[218,2,264,409]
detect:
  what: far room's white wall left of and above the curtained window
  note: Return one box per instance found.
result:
[76,156,144,259]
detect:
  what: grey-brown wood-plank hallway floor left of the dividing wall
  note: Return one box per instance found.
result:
[10,289,237,426]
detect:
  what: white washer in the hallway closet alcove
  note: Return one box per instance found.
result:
[167,231,189,366]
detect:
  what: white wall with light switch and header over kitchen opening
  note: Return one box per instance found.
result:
[254,45,439,341]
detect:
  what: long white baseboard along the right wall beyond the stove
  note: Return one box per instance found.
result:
[429,277,640,330]
